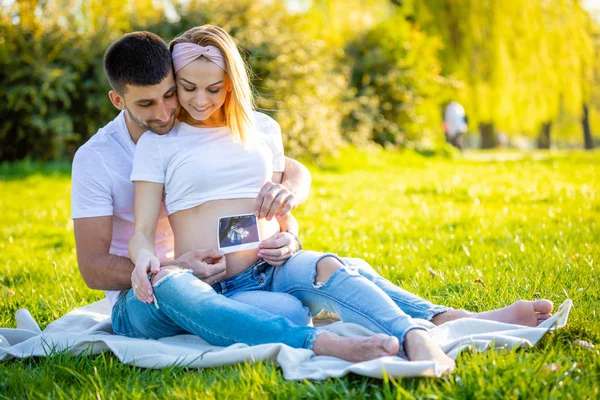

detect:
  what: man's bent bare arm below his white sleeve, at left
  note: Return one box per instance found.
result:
[73,216,133,290]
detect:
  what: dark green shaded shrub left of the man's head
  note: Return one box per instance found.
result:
[0,10,124,161]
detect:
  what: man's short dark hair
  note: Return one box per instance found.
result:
[104,32,172,95]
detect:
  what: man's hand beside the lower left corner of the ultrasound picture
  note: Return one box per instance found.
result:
[171,249,226,285]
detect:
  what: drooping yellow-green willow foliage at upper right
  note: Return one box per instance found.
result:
[410,0,592,147]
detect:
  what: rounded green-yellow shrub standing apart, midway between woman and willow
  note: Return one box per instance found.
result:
[343,15,447,146]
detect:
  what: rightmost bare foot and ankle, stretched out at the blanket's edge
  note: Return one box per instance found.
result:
[431,300,554,326]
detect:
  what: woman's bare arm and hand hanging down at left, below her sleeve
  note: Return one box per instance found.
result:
[129,181,164,303]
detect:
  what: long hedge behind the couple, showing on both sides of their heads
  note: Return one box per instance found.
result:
[0,0,347,161]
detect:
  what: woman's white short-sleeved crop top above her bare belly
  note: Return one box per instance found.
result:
[131,112,285,215]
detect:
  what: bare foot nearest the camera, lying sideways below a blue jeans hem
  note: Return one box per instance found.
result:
[313,332,400,362]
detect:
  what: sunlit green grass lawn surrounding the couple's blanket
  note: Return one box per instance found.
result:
[0,149,600,399]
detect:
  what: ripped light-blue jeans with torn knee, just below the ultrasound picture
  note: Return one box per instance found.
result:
[212,251,444,348]
